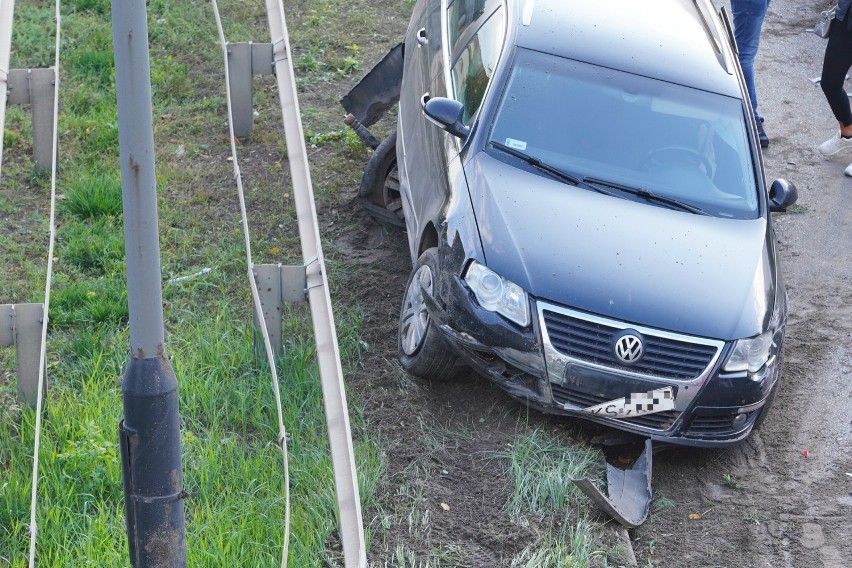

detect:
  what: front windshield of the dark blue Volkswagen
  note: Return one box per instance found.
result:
[489,50,758,219]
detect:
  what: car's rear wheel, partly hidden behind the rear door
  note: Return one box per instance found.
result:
[358,130,405,227]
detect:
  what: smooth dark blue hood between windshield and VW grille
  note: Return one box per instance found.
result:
[465,152,776,340]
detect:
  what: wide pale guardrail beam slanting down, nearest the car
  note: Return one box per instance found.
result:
[266,0,367,568]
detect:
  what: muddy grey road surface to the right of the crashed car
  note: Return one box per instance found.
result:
[632,0,852,568]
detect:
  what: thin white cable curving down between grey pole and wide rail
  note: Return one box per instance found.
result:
[210,0,290,568]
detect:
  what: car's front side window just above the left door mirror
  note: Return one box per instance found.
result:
[452,10,504,124]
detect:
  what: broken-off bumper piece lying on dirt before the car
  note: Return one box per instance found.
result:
[571,439,652,529]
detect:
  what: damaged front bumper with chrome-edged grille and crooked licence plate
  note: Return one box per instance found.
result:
[425,266,780,446]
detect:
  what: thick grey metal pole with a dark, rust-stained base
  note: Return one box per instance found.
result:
[112,0,186,568]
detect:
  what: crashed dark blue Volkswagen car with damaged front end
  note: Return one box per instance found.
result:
[348,0,796,445]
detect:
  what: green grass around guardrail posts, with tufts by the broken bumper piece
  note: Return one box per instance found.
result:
[0,0,601,568]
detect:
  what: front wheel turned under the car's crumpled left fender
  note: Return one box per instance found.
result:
[398,248,458,381]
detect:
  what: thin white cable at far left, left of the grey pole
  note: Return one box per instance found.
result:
[30,0,61,568]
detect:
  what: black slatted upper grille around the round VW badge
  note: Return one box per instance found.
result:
[542,309,718,380]
